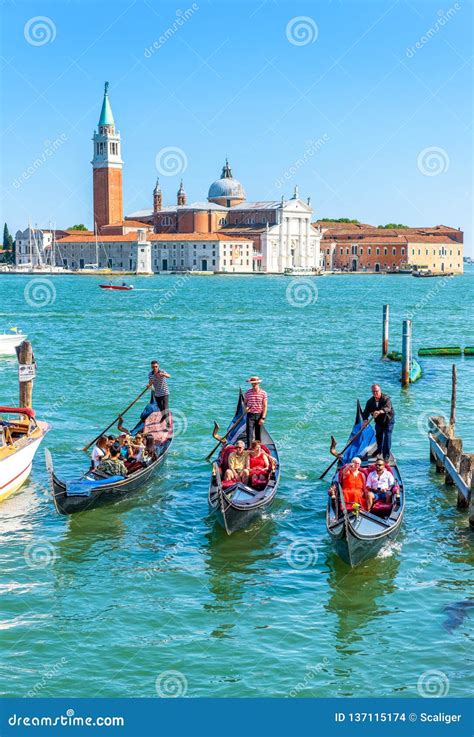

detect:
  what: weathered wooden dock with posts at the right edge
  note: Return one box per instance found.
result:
[428,365,474,529]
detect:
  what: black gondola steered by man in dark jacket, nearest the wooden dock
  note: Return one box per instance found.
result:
[326,402,405,568]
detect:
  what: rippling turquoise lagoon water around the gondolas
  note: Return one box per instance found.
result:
[0,270,474,697]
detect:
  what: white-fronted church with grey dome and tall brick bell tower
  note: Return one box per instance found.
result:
[88,83,322,273]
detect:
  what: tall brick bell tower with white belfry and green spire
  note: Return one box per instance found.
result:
[91,82,123,232]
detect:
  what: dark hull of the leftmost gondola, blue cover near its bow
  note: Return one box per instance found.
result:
[45,412,173,515]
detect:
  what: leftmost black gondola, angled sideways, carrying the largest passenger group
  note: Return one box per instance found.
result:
[45,405,173,515]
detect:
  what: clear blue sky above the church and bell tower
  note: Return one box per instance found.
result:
[1,0,472,252]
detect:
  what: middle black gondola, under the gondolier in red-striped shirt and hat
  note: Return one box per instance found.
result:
[208,391,280,535]
